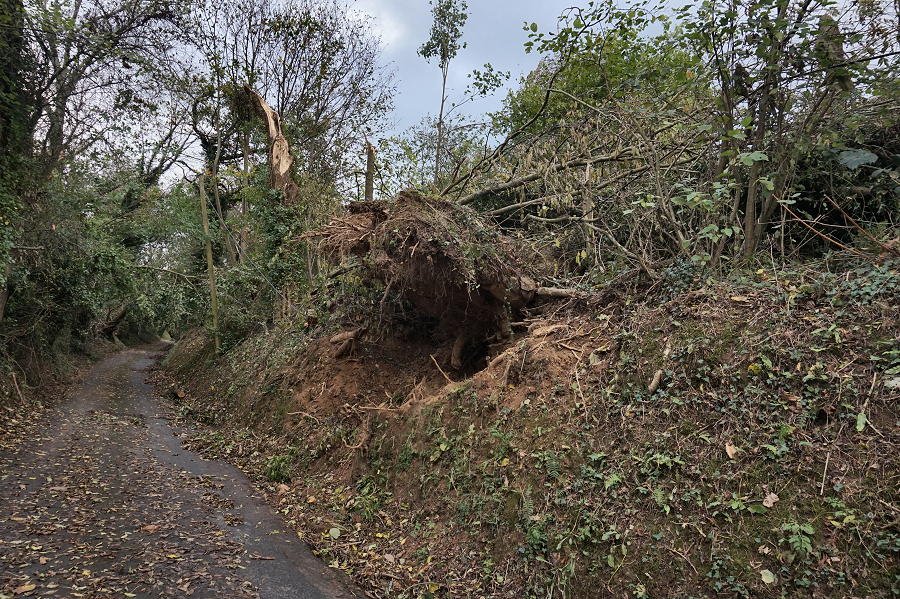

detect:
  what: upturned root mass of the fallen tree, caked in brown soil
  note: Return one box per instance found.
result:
[311,190,576,370]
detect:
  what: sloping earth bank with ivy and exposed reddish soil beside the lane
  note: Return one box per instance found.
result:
[168,256,900,597]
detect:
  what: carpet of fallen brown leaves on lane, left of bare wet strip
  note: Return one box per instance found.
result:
[0,354,266,599]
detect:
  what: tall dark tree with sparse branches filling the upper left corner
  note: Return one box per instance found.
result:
[0,0,176,328]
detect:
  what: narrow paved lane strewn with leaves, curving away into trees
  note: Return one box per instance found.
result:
[0,344,362,599]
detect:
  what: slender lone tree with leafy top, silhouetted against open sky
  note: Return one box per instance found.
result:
[419,0,469,187]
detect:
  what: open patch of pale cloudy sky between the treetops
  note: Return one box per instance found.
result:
[353,0,586,137]
